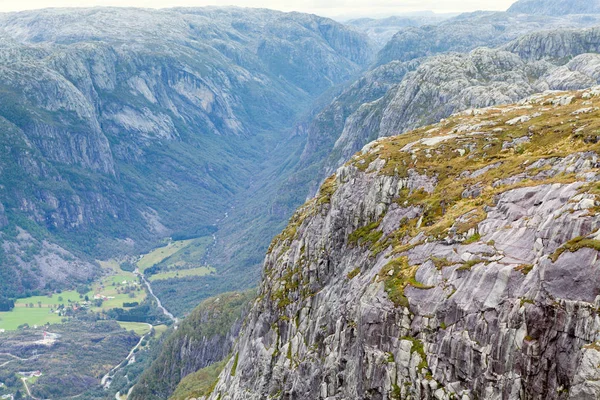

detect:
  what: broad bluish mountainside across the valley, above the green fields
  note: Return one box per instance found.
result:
[0,8,370,296]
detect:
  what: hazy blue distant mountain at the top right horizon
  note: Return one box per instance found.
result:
[508,0,600,15]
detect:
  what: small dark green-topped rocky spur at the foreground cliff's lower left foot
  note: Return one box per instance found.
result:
[129,291,256,400]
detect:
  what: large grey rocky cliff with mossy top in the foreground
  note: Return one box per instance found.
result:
[210,88,600,400]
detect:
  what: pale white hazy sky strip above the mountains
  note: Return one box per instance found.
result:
[0,0,515,17]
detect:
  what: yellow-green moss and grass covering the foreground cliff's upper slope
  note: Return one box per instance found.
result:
[348,92,600,250]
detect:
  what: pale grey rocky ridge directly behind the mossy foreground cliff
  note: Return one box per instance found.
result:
[296,28,600,197]
